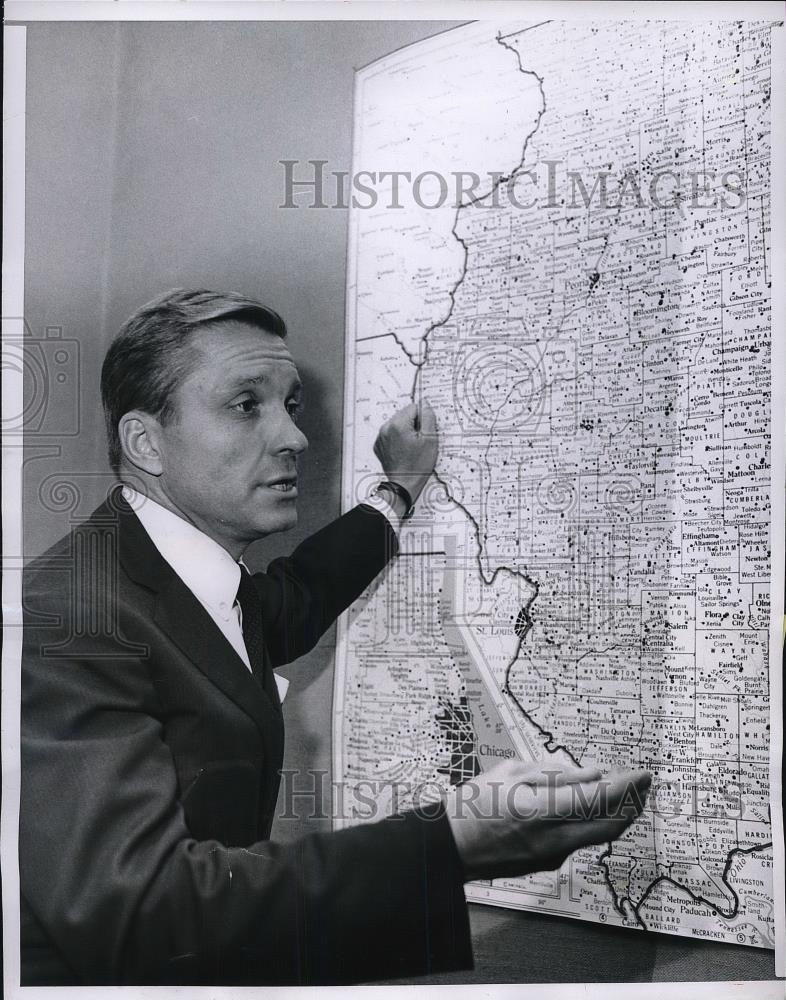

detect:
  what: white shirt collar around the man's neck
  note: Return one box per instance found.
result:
[123,486,240,618]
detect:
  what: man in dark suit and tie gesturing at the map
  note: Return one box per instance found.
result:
[20,290,648,985]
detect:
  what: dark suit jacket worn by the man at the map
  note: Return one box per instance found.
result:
[19,491,472,985]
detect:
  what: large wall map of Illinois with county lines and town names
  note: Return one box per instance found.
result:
[334,22,774,947]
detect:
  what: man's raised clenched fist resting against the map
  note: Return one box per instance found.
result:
[374,399,439,503]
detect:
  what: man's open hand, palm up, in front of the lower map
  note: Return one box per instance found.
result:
[447,761,651,880]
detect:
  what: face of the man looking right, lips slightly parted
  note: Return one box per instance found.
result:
[152,321,308,555]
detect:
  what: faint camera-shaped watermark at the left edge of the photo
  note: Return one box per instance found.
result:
[2,317,81,434]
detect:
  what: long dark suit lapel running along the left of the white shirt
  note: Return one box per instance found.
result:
[108,489,283,759]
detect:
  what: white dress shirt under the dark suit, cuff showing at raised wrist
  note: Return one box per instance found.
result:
[123,486,401,702]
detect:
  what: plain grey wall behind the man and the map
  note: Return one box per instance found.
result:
[18,21,774,983]
